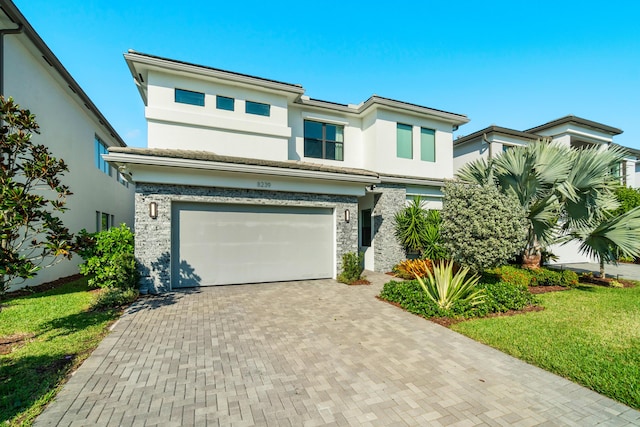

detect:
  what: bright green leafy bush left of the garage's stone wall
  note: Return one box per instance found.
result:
[78,224,138,289]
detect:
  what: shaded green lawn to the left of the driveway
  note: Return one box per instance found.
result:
[0,279,120,425]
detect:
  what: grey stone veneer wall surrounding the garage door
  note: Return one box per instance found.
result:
[135,183,358,293]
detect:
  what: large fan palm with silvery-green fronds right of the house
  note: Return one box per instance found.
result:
[457,141,625,267]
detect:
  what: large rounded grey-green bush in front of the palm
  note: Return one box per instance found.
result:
[441,182,527,271]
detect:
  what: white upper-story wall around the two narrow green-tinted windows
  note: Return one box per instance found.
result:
[364,109,453,179]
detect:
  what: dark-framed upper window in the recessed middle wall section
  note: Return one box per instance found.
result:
[304,120,344,160]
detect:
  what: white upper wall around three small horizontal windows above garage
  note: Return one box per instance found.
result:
[145,71,291,160]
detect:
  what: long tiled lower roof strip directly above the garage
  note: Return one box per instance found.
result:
[109,147,378,179]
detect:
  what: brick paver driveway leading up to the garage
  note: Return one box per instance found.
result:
[36,274,640,426]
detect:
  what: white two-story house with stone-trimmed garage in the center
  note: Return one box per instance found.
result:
[105,51,468,292]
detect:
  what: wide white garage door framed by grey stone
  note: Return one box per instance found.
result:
[171,203,335,288]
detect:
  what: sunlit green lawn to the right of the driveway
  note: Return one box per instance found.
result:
[451,286,640,409]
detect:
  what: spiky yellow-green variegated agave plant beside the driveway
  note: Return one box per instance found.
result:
[415,261,484,310]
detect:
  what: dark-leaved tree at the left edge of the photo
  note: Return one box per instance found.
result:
[0,96,73,295]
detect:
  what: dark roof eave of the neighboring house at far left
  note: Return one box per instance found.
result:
[0,0,127,147]
